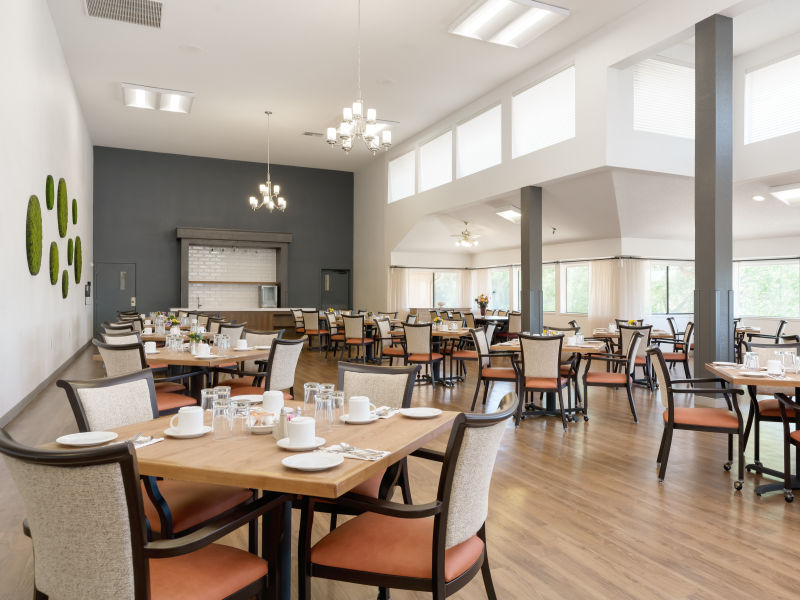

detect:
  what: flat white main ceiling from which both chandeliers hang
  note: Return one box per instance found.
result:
[49,0,645,170]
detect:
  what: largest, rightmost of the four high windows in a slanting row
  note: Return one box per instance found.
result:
[511,67,575,158]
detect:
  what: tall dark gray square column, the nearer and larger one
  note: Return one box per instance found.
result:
[692,15,733,377]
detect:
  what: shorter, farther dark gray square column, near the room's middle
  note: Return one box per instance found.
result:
[520,185,542,333]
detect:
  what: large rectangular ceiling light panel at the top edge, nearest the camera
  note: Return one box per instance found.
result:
[449,0,569,48]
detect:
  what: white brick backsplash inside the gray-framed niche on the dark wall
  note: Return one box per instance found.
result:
[189,245,278,310]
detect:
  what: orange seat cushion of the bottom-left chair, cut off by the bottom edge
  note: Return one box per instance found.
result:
[149,544,267,600]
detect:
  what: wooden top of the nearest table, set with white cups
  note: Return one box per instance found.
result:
[43,402,459,498]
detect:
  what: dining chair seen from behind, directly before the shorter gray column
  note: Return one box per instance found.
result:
[516,333,572,431]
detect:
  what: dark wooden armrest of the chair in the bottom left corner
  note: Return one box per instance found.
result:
[144,493,292,558]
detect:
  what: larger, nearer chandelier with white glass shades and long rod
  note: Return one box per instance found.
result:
[327,0,392,156]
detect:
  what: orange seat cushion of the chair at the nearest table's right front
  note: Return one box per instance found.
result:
[311,513,483,581]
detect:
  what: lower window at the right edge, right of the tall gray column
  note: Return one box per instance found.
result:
[734,260,800,317]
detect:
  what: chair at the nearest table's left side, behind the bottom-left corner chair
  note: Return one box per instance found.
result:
[56,370,255,543]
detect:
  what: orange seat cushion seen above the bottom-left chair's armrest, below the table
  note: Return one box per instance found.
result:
[142,479,253,533]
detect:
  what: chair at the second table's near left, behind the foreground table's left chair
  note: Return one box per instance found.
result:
[92,340,195,415]
